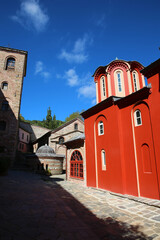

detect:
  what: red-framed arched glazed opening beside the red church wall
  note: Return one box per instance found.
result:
[70,150,83,179]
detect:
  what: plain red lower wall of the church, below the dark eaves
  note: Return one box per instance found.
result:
[85,92,160,199]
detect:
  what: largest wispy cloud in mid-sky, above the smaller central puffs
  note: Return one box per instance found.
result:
[59,35,92,63]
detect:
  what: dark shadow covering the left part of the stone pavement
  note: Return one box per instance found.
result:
[0,172,149,240]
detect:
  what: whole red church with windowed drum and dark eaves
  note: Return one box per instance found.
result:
[82,59,160,199]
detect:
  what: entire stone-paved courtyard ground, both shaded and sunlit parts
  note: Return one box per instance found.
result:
[0,171,160,240]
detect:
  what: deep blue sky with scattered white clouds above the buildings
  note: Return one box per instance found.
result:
[0,0,160,121]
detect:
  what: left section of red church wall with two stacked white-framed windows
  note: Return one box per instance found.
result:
[85,106,123,195]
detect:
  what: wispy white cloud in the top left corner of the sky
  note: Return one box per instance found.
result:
[11,0,49,32]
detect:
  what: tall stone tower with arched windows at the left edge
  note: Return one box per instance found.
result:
[0,47,28,162]
